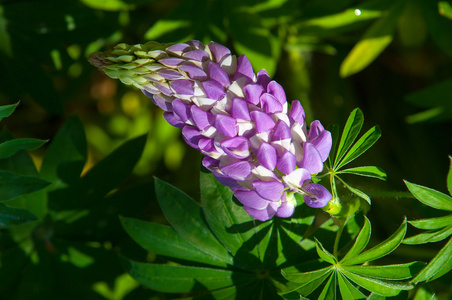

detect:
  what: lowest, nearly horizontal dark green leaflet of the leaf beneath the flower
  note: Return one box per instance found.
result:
[124,260,249,293]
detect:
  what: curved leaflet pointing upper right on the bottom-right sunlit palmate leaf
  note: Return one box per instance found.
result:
[347,219,407,265]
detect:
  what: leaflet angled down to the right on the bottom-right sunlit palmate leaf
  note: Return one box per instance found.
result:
[341,269,414,296]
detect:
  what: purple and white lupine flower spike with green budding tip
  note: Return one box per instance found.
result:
[90,41,331,221]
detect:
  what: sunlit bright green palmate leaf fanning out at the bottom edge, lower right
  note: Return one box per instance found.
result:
[282,218,418,299]
